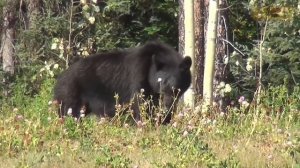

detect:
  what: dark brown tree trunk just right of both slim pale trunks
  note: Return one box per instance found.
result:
[213,0,230,112]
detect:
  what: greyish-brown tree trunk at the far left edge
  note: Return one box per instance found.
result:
[0,0,16,75]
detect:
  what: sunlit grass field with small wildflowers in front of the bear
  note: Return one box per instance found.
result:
[0,79,300,168]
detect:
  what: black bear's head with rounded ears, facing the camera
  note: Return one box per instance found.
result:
[148,42,192,109]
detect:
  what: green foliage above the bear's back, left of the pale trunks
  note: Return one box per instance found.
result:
[0,0,177,102]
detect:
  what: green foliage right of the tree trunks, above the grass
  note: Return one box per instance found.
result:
[230,0,300,99]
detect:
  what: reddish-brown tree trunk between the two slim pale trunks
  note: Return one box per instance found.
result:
[194,0,205,100]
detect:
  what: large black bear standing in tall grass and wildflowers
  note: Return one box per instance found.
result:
[54,41,192,123]
